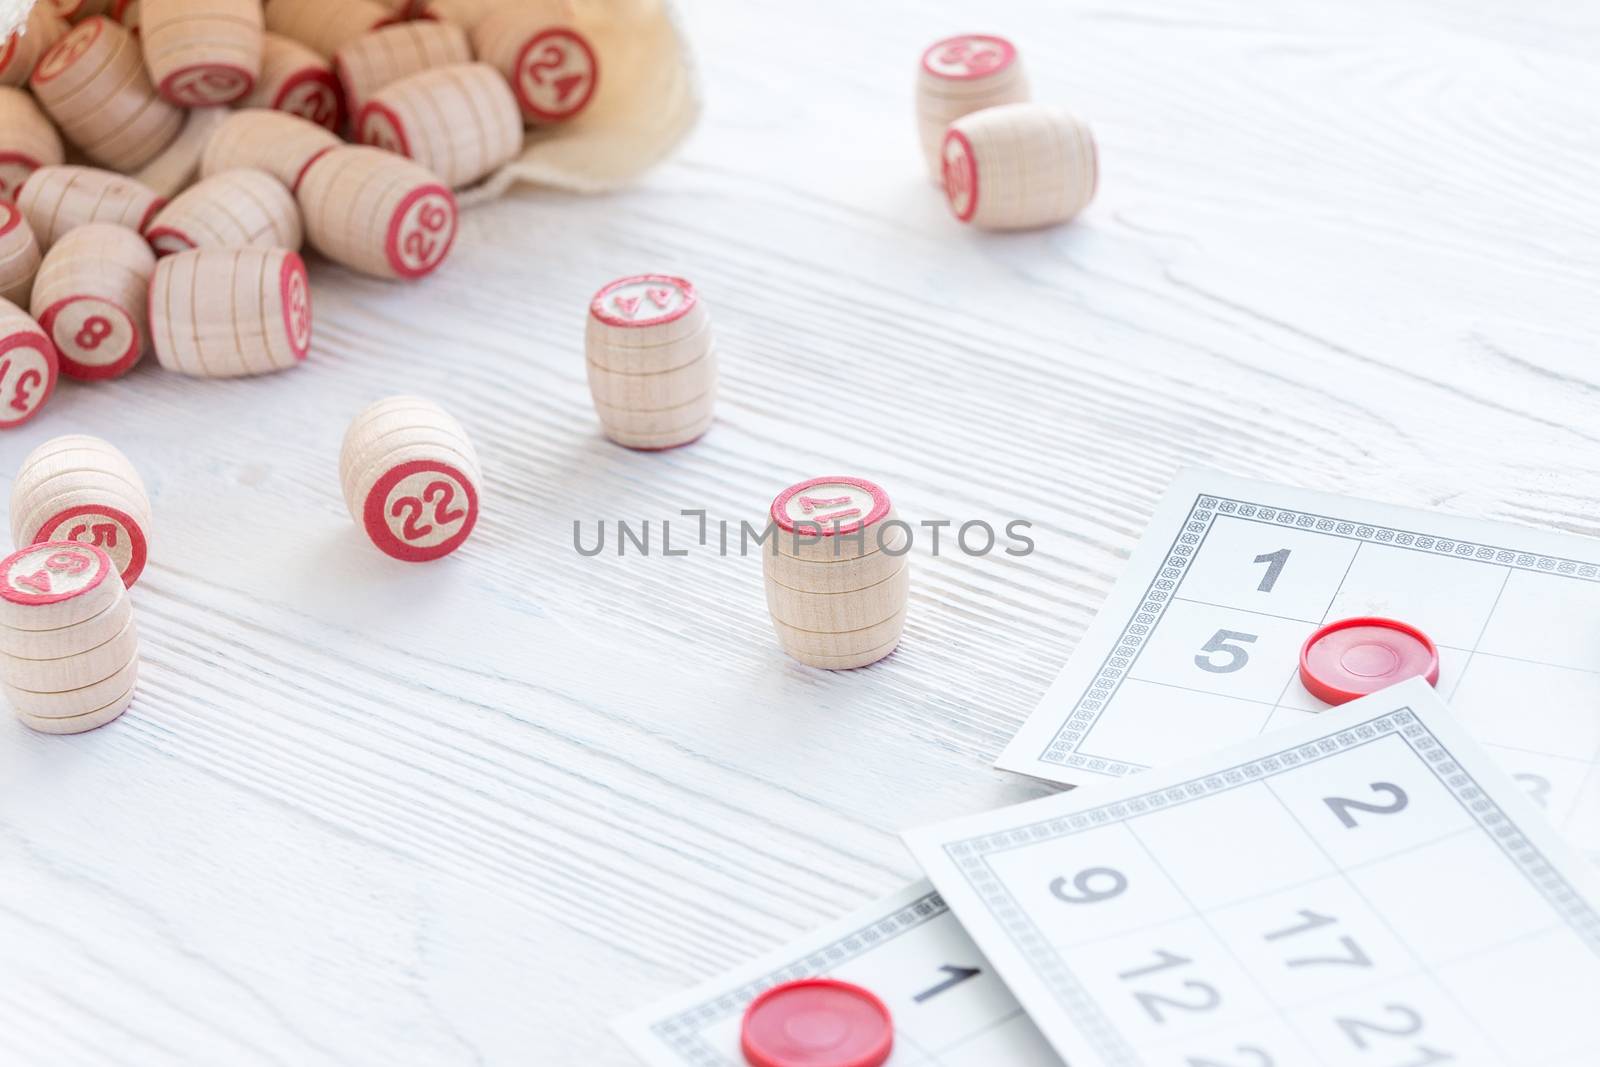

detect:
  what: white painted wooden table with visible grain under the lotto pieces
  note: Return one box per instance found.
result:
[0,0,1600,1065]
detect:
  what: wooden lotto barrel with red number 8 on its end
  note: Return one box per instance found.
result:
[30,222,155,381]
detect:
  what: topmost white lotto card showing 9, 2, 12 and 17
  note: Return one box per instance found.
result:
[907,678,1600,1067]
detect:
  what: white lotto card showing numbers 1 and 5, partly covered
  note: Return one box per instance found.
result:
[998,470,1600,857]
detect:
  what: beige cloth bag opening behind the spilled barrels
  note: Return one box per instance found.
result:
[0,0,701,205]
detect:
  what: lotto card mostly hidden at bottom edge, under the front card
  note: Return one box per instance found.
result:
[616,881,1062,1067]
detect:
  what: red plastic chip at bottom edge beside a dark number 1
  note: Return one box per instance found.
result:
[739,977,894,1067]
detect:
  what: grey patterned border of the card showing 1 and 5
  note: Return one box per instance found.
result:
[1038,493,1600,777]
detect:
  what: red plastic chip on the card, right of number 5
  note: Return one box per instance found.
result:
[1301,617,1438,704]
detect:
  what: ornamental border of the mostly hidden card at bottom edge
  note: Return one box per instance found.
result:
[650,891,949,1067]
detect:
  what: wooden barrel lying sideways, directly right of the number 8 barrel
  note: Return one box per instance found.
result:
[150,248,312,378]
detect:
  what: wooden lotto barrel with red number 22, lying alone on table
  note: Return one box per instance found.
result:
[339,397,483,563]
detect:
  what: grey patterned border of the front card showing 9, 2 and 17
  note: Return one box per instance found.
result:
[942,707,1600,1067]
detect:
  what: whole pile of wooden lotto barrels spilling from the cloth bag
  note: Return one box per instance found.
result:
[0,0,600,429]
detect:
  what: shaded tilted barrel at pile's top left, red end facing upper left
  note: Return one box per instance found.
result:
[29,14,184,171]
